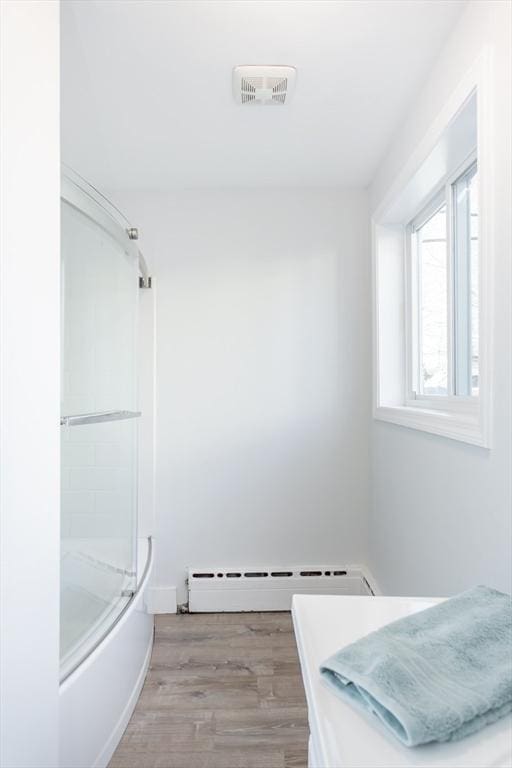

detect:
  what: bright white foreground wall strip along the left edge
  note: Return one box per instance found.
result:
[0,0,60,768]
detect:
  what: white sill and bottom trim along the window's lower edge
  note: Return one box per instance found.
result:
[374,405,490,448]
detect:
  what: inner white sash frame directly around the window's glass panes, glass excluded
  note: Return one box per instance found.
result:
[404,149,480,415]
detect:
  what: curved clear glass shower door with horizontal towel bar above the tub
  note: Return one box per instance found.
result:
[61,190,138,678]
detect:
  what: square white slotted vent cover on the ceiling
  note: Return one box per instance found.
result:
[233,65,297,105]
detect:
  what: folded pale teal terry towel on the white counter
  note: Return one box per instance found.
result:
[320,586,512,747]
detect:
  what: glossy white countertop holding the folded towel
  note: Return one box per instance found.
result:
[292,595,512,768]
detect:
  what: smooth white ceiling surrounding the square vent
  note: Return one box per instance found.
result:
[62,0,465,189]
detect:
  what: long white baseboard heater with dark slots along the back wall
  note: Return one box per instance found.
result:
[188,566,374,613]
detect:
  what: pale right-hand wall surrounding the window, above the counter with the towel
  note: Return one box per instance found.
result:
[369,0,512,595]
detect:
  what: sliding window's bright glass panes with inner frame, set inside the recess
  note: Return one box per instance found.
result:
[406,158,479,408]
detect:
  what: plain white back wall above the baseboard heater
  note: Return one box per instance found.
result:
[113,189,370,600]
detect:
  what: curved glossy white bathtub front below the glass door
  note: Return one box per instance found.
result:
[59,540,153,768]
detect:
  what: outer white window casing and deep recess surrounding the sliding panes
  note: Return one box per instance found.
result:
[372,49,494,448]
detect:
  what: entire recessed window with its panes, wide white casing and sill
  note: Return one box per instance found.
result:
[372,79,496,448]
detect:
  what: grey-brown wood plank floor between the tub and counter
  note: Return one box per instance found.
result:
[109,613,309,768]
